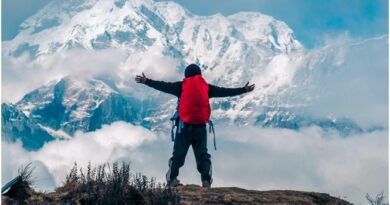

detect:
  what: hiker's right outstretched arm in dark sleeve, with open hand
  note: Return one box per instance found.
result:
[209,82,255,98]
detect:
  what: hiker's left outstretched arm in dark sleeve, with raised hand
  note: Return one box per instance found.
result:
[135,73,182,97]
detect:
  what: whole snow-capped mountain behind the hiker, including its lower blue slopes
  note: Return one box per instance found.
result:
[2,0,382,148]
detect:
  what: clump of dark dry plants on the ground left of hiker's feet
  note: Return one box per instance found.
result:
[57,162,179,205]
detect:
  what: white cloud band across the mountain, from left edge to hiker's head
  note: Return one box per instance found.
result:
[2,46,183,103]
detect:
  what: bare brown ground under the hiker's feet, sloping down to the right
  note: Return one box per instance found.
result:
[177,185,351,205]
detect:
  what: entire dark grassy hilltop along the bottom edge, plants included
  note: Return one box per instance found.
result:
[2,162,360,205]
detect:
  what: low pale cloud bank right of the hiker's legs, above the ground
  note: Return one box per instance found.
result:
[214,124,389,203]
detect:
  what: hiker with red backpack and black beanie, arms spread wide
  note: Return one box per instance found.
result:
[135,64,255,187]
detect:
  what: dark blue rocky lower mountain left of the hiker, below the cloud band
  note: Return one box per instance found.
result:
[1,77,139,150]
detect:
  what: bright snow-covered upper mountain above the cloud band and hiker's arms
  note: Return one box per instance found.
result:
[3,0,303,114]
